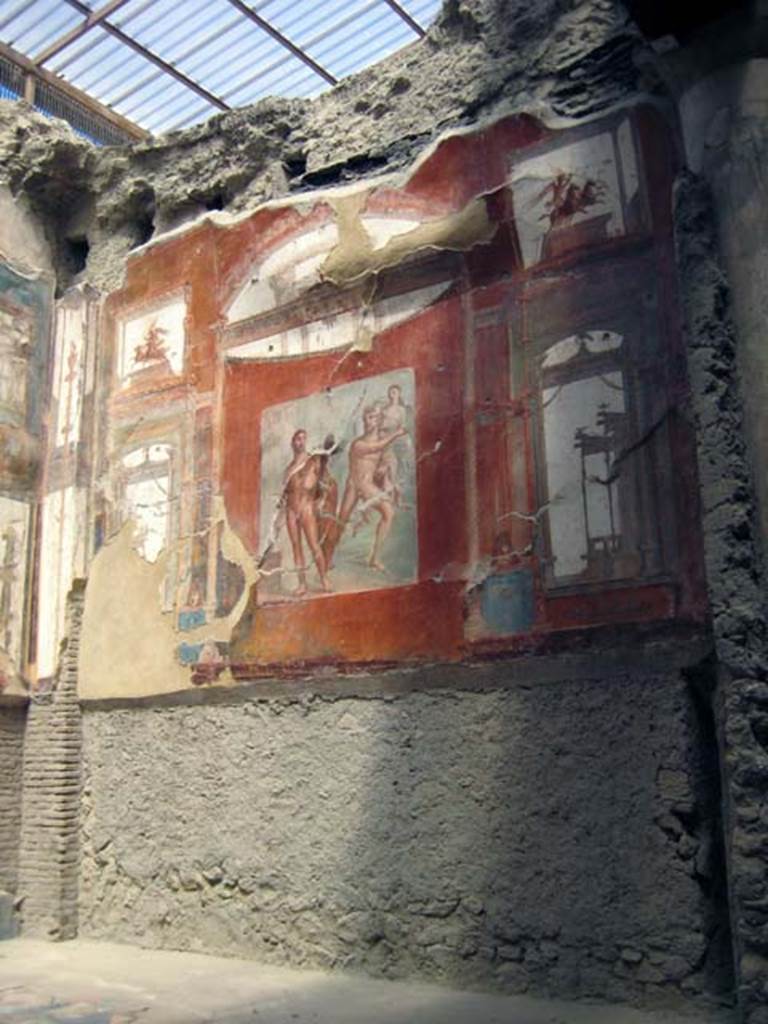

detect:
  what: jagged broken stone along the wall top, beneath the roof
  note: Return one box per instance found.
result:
[0,0,655,290]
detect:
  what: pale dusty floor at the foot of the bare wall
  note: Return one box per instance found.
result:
[0,939,731,1024]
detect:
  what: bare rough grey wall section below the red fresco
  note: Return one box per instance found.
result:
[80,667,731,1001]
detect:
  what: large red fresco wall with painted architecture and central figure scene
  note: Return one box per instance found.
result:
[19,106,706,696]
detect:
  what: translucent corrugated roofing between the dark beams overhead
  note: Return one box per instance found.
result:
[0,0,440,139]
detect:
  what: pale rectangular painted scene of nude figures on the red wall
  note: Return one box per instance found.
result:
[258,370,418,602]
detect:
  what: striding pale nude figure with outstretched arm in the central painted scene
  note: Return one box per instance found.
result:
[339,399,407,571]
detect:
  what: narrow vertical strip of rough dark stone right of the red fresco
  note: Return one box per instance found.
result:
[676,175,768,1024]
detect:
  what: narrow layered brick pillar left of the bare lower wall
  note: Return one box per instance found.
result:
[18,591,83,939]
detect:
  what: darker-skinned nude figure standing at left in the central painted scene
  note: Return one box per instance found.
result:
[281,429,338,597]
